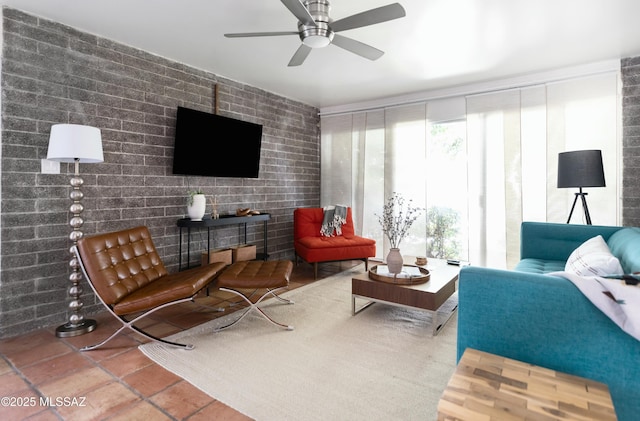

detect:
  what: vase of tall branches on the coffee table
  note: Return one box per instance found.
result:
[378,192,422,273]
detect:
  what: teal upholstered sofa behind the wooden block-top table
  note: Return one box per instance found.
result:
[457,222,640,421]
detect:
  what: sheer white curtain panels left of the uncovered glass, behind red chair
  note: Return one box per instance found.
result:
[320,104,426,257]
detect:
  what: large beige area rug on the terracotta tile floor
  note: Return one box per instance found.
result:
[140,266,457,421]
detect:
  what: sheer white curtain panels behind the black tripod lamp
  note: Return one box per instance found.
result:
[467,73,620,267]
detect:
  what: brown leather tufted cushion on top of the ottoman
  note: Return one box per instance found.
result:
[216,260,293,289]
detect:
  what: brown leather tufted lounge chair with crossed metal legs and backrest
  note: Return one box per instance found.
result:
[74,226,225,351]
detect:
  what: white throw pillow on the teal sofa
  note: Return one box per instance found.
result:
[564,235,624,276]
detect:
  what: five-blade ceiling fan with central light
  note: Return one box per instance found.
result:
[224,0,405,66]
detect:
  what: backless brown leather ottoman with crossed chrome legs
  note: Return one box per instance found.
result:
[216,260,293,331]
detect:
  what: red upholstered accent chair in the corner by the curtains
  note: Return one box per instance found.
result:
[293,208,376,279]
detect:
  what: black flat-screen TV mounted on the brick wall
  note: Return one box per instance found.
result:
[173,107,262,178]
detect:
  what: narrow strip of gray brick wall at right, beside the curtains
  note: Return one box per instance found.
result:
[621,57,640,227]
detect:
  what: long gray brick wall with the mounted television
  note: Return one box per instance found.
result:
[0,8,320,337]
